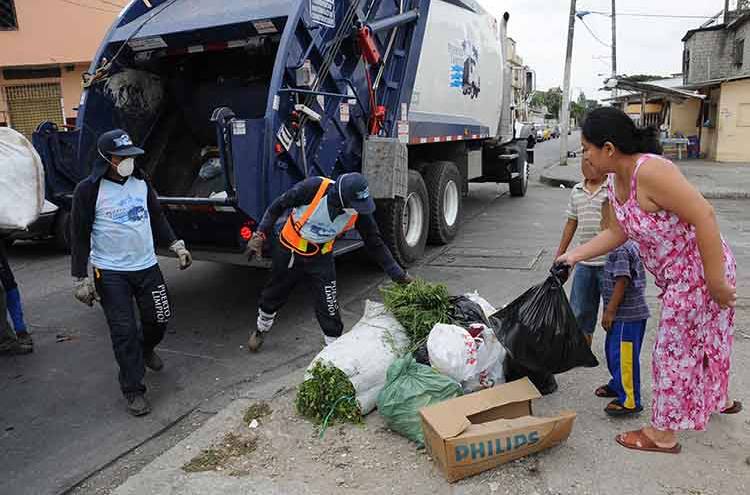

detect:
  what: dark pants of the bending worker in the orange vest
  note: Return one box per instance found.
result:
[260,241,344,337]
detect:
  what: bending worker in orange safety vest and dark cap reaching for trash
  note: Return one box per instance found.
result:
[246,173,411,352]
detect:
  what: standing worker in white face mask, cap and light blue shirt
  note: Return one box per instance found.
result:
[71,129,192,416]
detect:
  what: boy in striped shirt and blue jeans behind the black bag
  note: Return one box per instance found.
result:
[557,155,607,345]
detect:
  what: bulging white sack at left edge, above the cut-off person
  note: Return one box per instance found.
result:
[0,127,44,230]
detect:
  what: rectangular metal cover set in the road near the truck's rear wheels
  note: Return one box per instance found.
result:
[428,247,545,270]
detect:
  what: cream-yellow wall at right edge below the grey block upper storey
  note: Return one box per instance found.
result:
[716,79,750,162]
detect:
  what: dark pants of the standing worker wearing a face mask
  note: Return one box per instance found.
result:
[94,265,172,397]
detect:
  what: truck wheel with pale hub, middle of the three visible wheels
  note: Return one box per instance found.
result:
[424,162,463,245]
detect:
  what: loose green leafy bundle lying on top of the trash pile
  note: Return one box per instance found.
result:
[381,279,451,348]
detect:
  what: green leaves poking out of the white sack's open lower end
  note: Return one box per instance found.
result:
[295,361,362,425]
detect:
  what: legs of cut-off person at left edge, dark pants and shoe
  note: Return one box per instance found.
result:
[0,239,34,354]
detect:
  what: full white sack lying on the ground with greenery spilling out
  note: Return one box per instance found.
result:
[305,301,409,414]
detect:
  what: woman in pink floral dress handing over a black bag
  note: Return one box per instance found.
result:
[558,107,742,453]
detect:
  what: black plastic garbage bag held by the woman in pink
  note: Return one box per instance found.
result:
[492,266,599,373]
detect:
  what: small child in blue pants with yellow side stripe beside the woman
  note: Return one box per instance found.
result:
[595,202,649,416]
